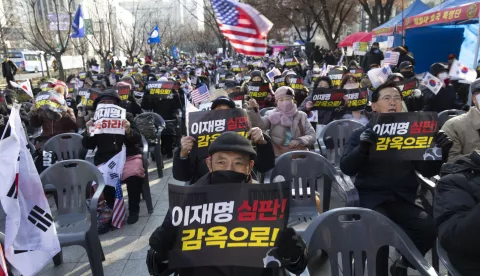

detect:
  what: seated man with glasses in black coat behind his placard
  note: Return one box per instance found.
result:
[340,80,452,276]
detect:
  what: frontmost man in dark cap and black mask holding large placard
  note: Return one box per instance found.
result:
[147,132,307,276]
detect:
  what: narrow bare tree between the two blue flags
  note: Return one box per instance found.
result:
[86,0,116,73]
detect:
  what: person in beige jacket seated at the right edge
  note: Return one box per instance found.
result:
[442,79,480,162]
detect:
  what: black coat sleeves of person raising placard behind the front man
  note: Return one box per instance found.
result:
[172,134,275,183]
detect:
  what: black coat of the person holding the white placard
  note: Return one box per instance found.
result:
[82,113,142,166]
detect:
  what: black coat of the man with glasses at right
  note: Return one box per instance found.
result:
[340,125,441,209]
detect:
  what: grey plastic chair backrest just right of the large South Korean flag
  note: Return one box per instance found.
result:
[40,159,104,215]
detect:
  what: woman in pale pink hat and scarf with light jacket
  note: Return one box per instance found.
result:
[248,86,316,156]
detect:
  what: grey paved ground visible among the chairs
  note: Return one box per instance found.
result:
[0,156,447,276]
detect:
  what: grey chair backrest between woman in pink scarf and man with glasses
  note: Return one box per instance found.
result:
[320,119,363,167]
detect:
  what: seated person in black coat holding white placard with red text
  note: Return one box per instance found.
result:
[82,89,145,224]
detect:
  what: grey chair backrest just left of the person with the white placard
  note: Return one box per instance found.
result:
[42,133,87,161]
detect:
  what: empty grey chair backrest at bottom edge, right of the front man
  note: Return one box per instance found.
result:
[303,208,437,276]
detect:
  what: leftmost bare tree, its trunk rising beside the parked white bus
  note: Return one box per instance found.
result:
[20,0,74,80]
